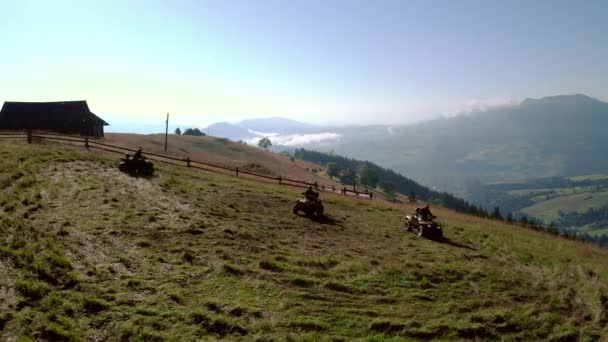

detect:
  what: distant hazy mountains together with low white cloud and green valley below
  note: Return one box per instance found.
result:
[202,94,608,223]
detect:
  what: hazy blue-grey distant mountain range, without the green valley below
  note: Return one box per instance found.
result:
[202,95,608,190]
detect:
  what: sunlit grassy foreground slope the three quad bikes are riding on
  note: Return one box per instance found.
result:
[0,144,608,341]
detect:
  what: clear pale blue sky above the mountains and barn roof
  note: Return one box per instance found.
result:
[0,0,608,130]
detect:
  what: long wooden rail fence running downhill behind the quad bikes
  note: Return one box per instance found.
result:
[0,131,373,199]
